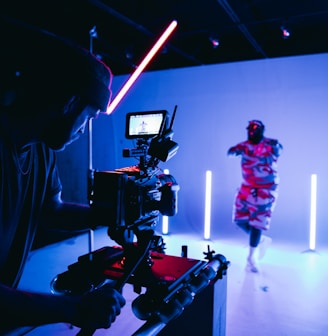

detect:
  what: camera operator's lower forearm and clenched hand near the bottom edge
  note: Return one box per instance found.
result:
[0,284,125,333]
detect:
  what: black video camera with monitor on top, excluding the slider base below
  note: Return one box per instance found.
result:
[91,110,179,244]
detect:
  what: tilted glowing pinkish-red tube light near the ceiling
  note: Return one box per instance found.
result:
[106,20,178,114]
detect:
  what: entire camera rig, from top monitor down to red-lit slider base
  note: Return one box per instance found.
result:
[51,107,229,336]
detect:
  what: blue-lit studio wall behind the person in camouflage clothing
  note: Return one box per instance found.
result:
[59,54,328,246]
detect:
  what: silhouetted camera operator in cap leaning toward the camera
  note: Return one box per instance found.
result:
[0,21,125,335]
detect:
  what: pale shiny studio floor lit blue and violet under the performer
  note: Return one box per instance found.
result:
[21,229,328,336]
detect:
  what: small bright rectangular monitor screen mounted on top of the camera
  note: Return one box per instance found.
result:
[125,110,167,139]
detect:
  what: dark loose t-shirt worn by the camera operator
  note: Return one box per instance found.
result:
[0,140,61,287]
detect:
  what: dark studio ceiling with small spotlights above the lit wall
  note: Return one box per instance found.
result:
[0,0,328,75]
